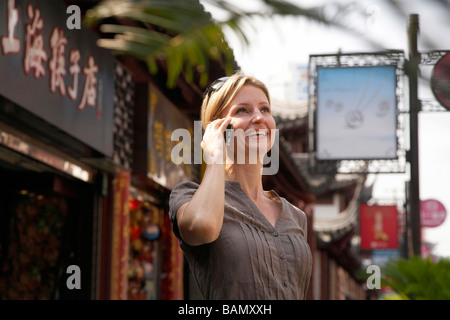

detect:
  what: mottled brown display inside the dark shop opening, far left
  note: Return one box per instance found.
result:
[0,190,68,300]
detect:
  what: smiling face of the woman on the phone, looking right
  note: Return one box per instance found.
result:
[221,85,276,160]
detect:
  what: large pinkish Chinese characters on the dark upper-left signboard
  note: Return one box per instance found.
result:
[0,0,102,118]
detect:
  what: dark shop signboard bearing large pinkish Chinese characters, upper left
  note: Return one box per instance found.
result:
[0,0,118,156]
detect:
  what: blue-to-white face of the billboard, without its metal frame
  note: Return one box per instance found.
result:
[316,66,398,160]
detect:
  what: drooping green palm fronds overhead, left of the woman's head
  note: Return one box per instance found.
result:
[85,0,233,87]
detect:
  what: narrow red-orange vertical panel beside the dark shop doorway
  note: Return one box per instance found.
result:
[111,171,130,300]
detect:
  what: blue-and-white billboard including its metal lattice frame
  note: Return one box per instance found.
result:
[308,50,409,173]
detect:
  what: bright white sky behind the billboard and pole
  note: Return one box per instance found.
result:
[205,0,450,257]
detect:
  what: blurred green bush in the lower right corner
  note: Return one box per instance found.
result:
[381,256,450,300]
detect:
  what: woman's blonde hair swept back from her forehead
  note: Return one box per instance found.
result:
[201,70,270,129]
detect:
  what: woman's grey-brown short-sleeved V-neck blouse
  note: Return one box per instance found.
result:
[169,181,312,300]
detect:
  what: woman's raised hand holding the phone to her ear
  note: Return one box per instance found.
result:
[201,118,231,164]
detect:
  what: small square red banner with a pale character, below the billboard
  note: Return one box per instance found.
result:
[359,204,398,250]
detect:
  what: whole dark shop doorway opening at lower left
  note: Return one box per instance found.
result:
[0,161,93,300]
